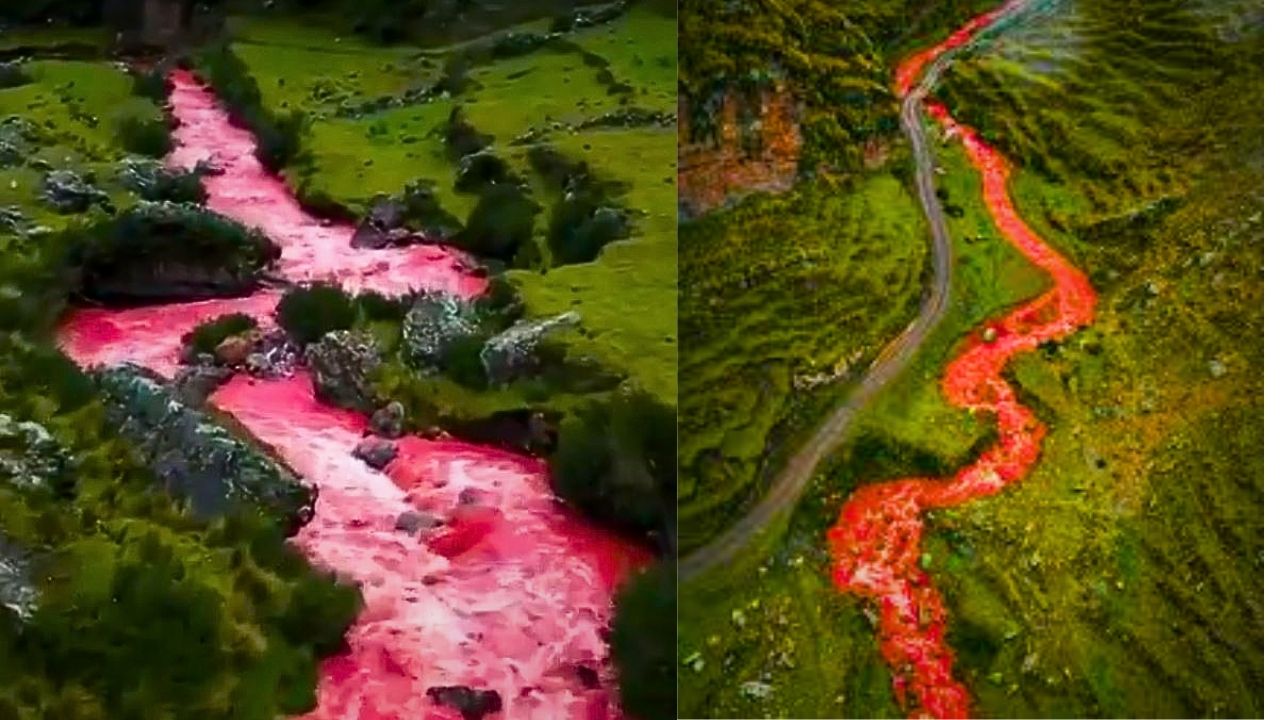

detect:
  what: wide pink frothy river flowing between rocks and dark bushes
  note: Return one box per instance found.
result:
[60,70,649,720]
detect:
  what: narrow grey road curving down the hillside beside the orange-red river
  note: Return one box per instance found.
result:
[678,0,1030,582]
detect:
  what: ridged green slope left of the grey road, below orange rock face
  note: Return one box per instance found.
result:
[680,173,928,552]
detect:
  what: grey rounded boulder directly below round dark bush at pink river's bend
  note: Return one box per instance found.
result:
[306,331,381,411]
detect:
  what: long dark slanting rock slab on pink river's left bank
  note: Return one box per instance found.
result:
[96,364,316,534]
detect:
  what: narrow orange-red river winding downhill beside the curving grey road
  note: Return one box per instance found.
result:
[827,3,1096,717]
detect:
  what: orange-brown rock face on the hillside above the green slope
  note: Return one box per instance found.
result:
[678,90,801,217]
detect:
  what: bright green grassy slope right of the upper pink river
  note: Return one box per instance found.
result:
[220,4,676,404]
